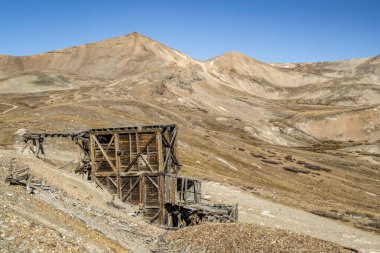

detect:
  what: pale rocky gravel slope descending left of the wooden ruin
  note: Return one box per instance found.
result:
[0,157,162,253]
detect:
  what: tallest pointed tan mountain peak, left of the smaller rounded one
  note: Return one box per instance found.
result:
[0,32,193,79]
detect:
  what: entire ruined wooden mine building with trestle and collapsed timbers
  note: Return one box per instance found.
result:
[23,124,238,227]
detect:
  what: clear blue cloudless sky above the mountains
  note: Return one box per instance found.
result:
[0,0,380,62]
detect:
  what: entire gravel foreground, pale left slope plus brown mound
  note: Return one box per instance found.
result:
[0,152,374,252]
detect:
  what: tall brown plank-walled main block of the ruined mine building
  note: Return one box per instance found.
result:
[89,125,180,223]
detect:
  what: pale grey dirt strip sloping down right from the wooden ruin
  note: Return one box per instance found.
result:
[202,182,380,253]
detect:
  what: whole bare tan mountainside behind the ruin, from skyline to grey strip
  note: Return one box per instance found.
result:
[0,33,380,235]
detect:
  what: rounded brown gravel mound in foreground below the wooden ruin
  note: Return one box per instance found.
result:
[157,223,355,253]
